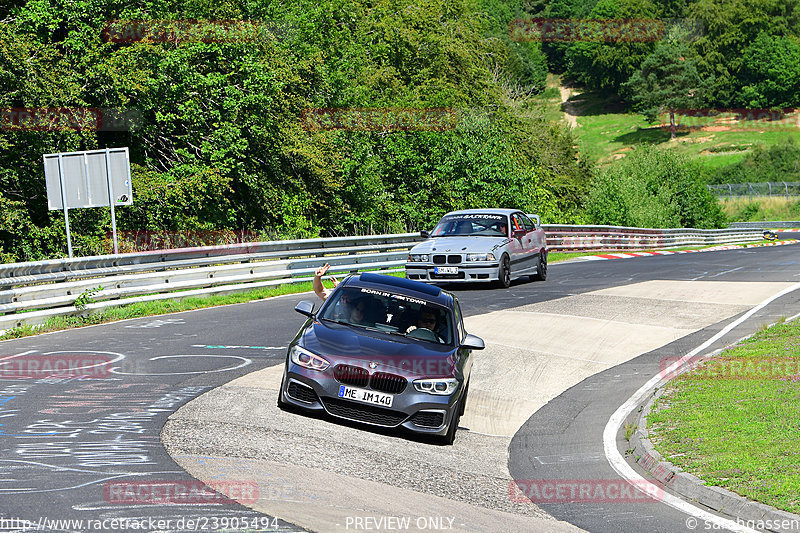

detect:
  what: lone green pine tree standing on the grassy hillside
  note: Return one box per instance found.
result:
[623,42,705,139]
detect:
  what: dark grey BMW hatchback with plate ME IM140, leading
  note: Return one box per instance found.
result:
[278,273,484,444]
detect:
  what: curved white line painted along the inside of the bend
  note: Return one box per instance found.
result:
[603,283,800,533]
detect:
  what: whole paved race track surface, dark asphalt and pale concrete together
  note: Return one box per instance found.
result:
[0,239,800,531]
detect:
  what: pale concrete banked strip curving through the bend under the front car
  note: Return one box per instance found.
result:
[162,281,789,532]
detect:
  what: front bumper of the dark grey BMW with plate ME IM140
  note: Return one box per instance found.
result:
[281,362,463,435]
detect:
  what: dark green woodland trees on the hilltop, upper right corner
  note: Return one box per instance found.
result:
[535,0,800,108]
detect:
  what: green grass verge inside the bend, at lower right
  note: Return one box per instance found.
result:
[648,320,800,513]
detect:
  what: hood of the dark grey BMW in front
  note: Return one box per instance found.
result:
[300,321,456,379]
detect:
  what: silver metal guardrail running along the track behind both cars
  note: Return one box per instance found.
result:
[0,224,761,330]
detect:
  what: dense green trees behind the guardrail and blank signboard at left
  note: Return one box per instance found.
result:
[0,0,590,260]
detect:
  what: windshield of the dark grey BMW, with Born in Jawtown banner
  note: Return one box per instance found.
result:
[318,287,454,345]
